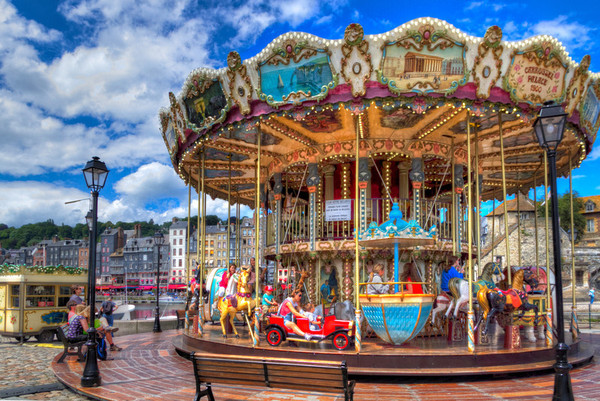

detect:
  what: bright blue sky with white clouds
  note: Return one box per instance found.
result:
[0,0,600,227]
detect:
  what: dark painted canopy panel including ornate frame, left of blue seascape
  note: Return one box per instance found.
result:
[183,74,230,131]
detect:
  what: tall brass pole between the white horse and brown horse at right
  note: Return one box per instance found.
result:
[467,110,475,352]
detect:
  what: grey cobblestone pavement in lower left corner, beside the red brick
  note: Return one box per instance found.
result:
[0,337,89,401]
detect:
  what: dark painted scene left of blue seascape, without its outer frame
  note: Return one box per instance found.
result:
[185,81,229,129]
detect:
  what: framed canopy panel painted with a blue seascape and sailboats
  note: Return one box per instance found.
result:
[258,40,338,107]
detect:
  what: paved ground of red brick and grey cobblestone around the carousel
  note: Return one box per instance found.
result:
[0,330,600,401]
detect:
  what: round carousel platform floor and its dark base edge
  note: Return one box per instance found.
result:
[173,322,594,376]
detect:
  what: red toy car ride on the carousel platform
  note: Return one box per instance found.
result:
[265,315,355,350]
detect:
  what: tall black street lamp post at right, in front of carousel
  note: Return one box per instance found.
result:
[533,102,573,400]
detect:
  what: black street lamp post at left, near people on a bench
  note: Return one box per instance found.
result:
[81,156,108,387]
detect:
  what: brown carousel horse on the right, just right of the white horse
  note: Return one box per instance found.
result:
[475,269,538,334]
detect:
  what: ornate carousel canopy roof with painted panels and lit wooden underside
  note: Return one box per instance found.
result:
[160,18,600,206]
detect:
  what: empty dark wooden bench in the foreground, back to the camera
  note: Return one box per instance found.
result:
[190,352,355,401]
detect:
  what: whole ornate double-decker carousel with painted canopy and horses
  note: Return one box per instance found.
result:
[160,18,600,375]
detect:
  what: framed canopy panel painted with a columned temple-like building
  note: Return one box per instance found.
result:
[378,25,469,94]
